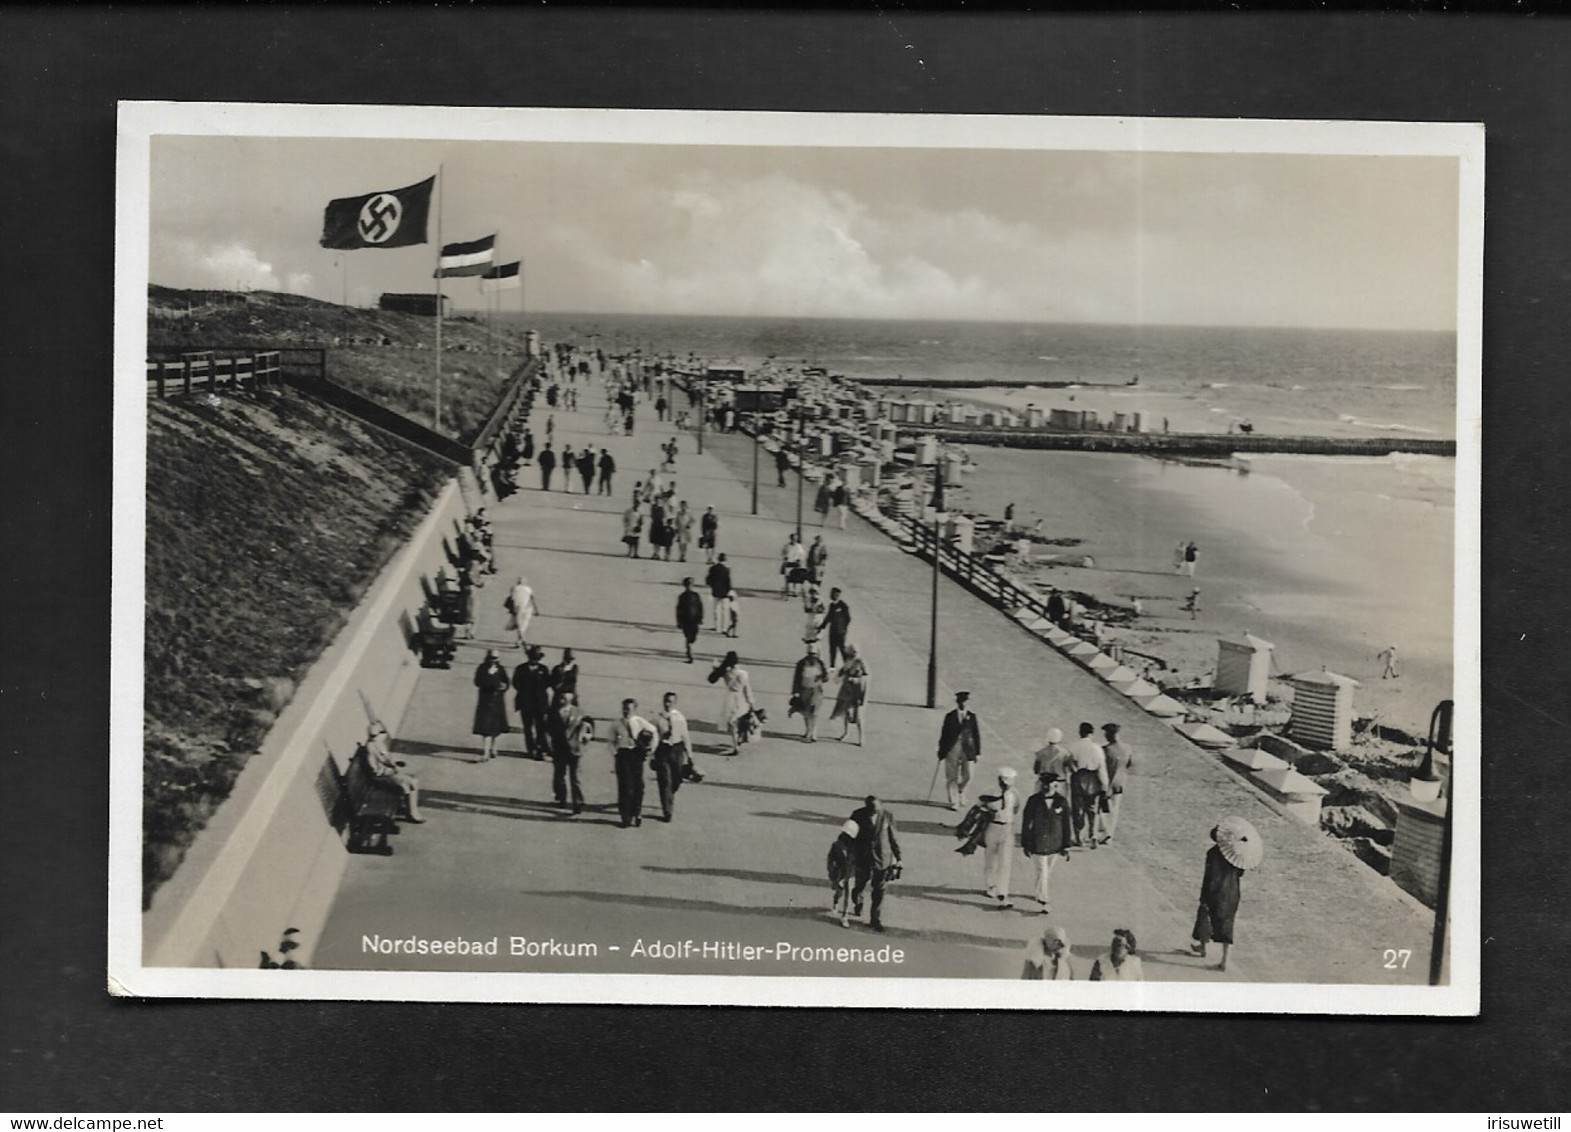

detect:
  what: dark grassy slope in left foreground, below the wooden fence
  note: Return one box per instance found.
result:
[143,393,451,903]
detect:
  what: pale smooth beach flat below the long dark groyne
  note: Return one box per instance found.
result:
[930,449,1455,735]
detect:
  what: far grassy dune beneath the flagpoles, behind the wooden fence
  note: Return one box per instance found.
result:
[148,286,523,441]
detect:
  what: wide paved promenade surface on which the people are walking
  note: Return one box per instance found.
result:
[313,378,1430,984]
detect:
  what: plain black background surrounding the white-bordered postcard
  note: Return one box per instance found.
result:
[0,5,1571,1112]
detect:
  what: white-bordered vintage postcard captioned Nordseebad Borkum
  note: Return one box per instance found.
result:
[108,104,1483,1014]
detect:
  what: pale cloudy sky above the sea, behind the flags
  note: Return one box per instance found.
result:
[149,137,1458,330]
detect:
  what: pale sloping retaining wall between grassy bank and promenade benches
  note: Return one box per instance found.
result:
[143,479,465,967]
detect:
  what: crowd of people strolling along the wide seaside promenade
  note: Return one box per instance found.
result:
[395,337,1263,980]
